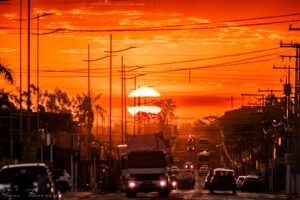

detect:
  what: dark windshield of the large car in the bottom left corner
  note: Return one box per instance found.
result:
[0,167,47,183]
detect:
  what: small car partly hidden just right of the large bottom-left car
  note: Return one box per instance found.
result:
[53,169,72,193]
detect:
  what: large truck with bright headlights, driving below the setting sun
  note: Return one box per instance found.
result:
[120,136,172,198]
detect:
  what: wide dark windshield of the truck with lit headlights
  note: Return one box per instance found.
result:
[128,151,167,168]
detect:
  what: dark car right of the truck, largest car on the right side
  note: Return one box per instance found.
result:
[209,168,236,194]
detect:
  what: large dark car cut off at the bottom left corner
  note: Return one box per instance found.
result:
[0,163,61,200]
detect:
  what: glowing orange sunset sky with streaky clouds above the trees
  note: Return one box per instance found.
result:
[0,0,300,120]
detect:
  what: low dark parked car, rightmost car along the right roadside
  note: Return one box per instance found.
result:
[241,175,264,192]
